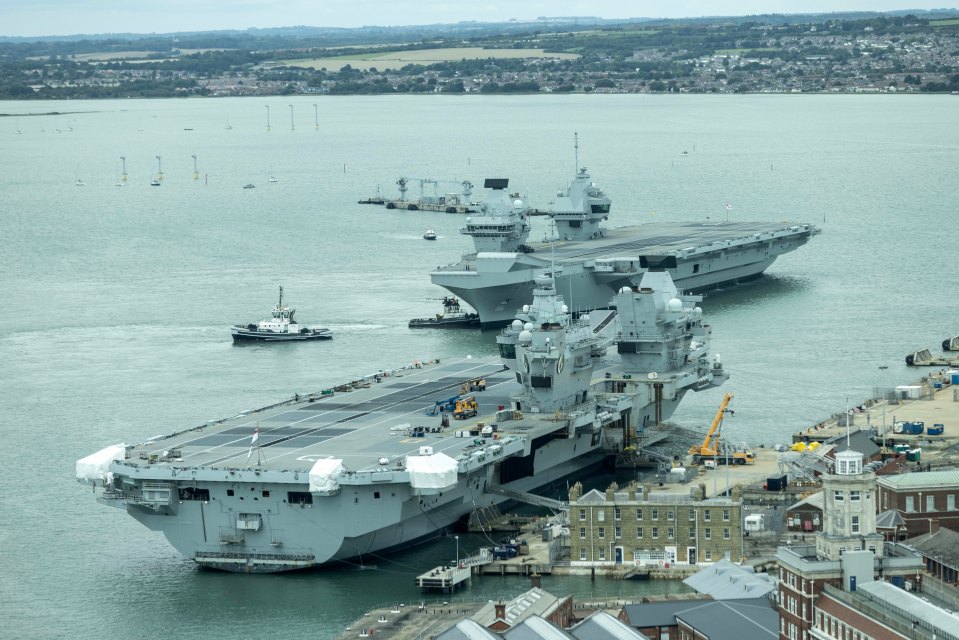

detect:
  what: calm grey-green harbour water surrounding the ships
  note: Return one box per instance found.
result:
[0,96,959,639]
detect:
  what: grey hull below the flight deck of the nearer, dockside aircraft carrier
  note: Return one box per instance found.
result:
[122,392,685,573]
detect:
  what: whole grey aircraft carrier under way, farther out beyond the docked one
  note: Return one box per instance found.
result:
[430,168,821,327]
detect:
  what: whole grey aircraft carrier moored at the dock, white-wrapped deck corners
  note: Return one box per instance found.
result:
[76,262,724,573]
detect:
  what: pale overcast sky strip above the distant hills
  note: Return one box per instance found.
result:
[0,0,949,36]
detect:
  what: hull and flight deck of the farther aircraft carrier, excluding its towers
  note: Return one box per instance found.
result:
[430,223,819,328]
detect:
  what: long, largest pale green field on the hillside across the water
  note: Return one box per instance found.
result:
[282,47,579,71]
